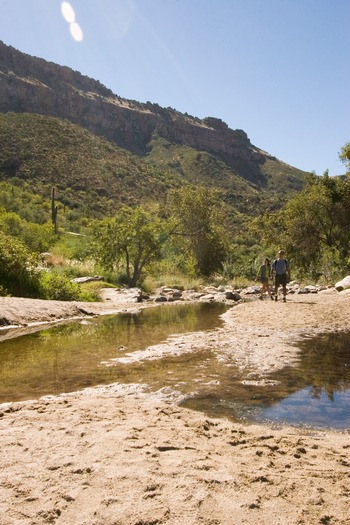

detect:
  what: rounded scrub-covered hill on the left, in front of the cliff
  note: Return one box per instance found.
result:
[0,113,189,216]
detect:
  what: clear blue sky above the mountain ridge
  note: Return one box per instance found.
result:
[0,0,350,175]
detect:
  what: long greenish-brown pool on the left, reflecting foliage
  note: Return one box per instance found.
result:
[0,304,227,402]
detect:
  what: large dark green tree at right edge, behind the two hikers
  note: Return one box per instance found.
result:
[253,171,350,276]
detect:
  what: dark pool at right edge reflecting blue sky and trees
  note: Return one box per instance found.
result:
[184,333,350,429]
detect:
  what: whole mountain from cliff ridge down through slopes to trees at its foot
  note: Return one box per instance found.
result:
[0,36,350,299]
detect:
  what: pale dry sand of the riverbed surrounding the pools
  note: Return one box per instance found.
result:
[0,290,350,525]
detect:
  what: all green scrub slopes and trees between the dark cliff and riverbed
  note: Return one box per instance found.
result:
[0,113,350,299]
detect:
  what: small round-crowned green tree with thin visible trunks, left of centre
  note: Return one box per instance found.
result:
[94,206,167,287]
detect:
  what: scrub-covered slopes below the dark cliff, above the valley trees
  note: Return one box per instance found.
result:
[0,113,304,223]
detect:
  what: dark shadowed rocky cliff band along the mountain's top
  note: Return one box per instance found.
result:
[0,41,292,186]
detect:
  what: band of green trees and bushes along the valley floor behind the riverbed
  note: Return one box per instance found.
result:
[0,143,350,298]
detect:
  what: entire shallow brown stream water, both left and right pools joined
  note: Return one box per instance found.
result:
[0,304,350,429]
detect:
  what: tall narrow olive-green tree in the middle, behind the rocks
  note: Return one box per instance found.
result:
[169,186,227,277]
